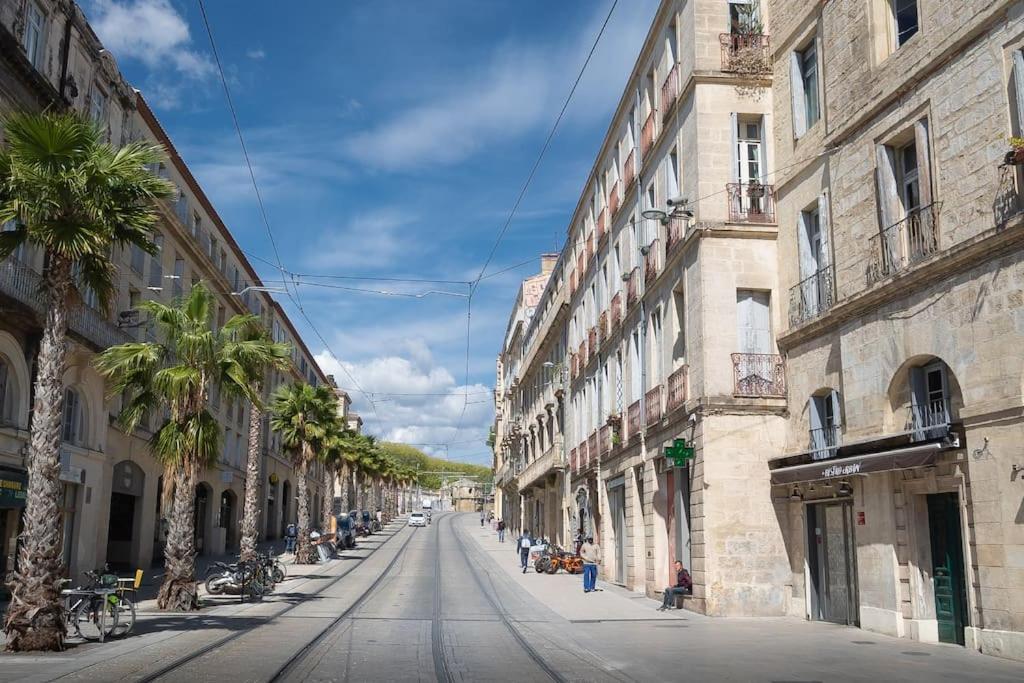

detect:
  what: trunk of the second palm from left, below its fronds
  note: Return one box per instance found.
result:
[157,464,199,611]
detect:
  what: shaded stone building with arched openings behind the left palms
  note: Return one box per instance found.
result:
[0,0,327,589]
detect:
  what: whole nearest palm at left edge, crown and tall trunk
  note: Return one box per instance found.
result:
[0,114,173,650]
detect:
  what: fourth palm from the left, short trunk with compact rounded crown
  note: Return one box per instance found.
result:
[270,382,338,564]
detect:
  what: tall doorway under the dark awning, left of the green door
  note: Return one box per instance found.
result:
[807,501,860,625]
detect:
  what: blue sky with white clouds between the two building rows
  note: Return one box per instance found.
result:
[88,0,657,465]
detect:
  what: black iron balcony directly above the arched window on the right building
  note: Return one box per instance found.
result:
[867,202,942,285]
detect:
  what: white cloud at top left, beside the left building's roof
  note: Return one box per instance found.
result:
[91,0,214,79]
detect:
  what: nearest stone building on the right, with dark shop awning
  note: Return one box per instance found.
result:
[769,0,1024,659]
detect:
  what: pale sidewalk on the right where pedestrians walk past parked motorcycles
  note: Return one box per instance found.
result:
[463,524,692,623]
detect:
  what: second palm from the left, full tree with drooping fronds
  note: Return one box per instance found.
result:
[95,284,276,611]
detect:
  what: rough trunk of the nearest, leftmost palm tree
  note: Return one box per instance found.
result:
[4,257,71,651]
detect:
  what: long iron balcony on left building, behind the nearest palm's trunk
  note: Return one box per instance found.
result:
[0,256,134,349]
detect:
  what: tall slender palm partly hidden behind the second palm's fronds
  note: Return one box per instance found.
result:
[225,327,292,560]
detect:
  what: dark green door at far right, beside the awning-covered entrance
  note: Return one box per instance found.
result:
[928,494,967,645]
